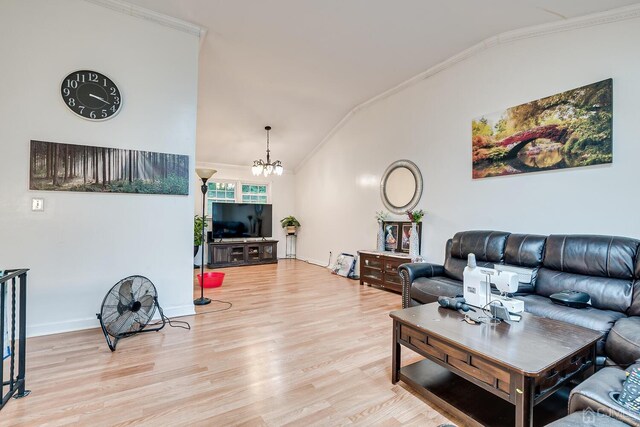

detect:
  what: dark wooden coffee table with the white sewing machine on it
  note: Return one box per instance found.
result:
[390,303,602,427]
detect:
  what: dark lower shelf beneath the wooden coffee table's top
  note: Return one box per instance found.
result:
[399,359,571,427]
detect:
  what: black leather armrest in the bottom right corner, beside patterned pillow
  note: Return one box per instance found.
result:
[569,367,640,426]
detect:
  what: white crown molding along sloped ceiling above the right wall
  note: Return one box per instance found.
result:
[295,4,640,173]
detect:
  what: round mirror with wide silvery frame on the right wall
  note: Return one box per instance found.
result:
[380,160,422,214]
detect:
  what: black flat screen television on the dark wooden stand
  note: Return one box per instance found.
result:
[211,203,273,239]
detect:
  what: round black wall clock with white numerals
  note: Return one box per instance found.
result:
[60,70,122,121]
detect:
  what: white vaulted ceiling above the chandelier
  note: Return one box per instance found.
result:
[128,0,637,171]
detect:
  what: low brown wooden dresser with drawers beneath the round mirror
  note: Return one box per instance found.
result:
[358,251,411,293]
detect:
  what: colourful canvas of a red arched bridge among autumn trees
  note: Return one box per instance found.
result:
[471,79,613,179]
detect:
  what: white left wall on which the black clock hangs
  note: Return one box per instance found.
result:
[0,0,198,335]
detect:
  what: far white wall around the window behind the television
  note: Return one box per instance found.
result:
[194,163,295,265]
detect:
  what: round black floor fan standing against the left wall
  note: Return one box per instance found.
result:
[96,276,166,351]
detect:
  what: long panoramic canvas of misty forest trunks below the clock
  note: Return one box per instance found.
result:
[29,141,189,195]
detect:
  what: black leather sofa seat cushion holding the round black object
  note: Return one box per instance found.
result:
[516,295,625,355]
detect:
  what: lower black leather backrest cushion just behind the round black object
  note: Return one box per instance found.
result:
[535,268,633,313]
